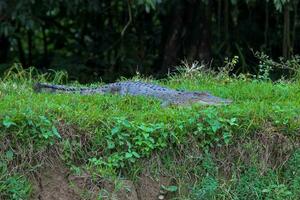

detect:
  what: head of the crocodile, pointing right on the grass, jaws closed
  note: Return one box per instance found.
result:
[186,92,232,105]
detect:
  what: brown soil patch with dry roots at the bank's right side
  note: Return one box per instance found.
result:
[212,123,300,177]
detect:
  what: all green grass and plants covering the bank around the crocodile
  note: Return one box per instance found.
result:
[0,66,300,199]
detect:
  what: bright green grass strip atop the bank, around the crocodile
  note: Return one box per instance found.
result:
[0,65,300,131]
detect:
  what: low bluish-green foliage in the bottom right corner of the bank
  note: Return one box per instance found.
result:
[191,152,300,200]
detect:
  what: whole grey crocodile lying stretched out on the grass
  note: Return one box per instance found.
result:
[34,81,232,106]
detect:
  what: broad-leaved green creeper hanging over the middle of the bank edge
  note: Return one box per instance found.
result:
[85,109,238,168]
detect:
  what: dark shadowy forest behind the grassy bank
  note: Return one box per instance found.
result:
[0,0,300,82]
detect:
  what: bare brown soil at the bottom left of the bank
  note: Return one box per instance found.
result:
[32,161,170,200]
